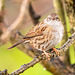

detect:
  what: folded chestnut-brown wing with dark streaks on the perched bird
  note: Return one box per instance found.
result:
[24,22,49,39]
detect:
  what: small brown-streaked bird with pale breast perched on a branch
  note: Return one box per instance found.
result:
[8,13,64,57]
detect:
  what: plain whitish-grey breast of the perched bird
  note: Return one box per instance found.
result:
[52,26,64,46]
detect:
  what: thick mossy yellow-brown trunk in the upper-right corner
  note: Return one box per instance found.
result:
[64,0,75,33]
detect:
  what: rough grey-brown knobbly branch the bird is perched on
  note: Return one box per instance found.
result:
[9,32,75,75]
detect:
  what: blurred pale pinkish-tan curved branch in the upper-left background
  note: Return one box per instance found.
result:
[1,0,30,40]
